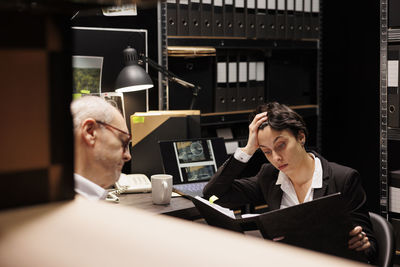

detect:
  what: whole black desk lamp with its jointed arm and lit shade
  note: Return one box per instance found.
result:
[115,46,201,109]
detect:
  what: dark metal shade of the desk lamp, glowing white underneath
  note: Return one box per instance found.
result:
[115,46,154,92]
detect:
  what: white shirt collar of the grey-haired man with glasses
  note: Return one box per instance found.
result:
[74,173,107,200]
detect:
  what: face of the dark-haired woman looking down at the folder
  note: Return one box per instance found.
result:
[258,126,305,177]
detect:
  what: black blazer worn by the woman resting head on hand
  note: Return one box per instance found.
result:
[203,151,377,261]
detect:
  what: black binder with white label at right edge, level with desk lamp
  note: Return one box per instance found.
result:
[387,45,400,128]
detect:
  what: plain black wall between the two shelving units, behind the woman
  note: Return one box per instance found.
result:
[321,0,380,214]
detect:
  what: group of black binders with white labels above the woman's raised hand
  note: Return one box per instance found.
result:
[214,52,265,112]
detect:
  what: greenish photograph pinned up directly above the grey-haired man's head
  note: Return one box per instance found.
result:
[72,56,103,96]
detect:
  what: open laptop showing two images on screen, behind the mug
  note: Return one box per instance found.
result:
[159,138,228,197]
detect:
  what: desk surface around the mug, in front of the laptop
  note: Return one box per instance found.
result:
[119,193,201,220]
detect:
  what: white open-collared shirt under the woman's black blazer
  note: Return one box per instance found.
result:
[276,153,322,209]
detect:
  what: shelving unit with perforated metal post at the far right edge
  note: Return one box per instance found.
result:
[380,0,400,264]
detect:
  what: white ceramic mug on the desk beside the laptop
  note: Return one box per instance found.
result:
[151,174,172,204]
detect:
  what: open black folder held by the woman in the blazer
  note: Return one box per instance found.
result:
[192,193,365,262]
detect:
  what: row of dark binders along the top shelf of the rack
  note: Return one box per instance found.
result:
[167,0,320,40]
